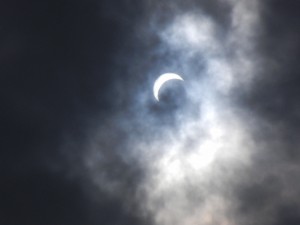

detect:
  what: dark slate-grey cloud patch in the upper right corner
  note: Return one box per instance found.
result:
[244,1,300,130]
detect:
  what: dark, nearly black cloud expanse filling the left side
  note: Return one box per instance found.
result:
[0,1,148,225]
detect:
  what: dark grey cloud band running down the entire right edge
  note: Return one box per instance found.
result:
[233,0,300,224]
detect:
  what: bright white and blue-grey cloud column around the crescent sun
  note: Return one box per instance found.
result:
[80,1,268,225]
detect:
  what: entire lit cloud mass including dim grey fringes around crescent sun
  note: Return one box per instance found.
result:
[52,0,299,225]
